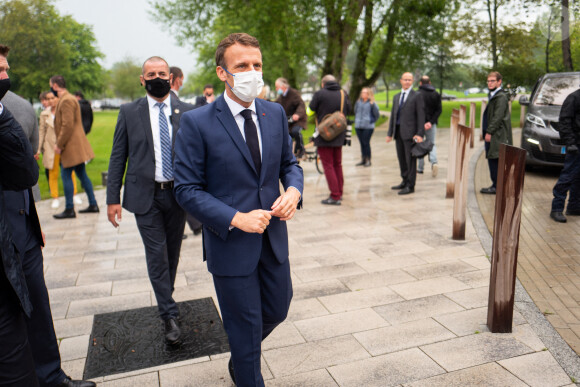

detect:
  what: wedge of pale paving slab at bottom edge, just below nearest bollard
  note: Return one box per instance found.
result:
[404,363,527,387]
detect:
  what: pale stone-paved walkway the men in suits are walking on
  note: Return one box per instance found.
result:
[38,124,580,387]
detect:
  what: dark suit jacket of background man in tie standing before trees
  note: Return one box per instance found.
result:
[387,90,425,140]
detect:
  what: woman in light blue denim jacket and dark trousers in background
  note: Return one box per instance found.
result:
[354,87,379,167]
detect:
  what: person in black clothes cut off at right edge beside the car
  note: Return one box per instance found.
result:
[550,89,580,223]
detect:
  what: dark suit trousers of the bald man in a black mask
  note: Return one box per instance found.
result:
[135,187,185,320]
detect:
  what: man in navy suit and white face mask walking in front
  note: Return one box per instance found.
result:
[175,33,304,386]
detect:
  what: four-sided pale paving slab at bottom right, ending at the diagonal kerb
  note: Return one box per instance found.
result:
[498,351,570,387]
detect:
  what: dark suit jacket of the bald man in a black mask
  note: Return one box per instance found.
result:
[107,96,193,214]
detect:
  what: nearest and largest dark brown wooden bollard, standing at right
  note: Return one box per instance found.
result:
[487,144,526,333]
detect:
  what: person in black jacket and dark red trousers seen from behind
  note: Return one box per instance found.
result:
[308,74,350,205]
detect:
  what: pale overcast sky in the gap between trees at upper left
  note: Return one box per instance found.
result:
[55,0,195,74]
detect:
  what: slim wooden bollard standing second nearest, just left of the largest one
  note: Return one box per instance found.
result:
[452,124,473,241]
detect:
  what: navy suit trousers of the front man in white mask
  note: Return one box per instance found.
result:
[213,231,292,387]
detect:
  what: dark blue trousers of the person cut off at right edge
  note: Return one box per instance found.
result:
[552,152,580,212]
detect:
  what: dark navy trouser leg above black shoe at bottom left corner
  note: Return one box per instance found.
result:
[22,245,66,386]
